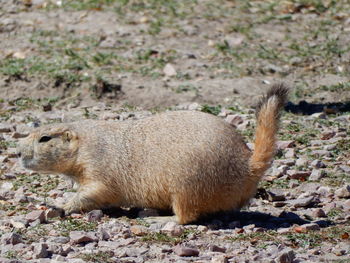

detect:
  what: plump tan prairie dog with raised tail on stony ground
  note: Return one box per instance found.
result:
[18,84,288,224]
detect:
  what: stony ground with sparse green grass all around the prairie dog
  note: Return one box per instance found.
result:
[0,0,350,262]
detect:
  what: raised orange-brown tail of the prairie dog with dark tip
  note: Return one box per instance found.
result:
[249,84,288,177]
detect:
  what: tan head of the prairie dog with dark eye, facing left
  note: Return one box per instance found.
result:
[17,126,78,173]
